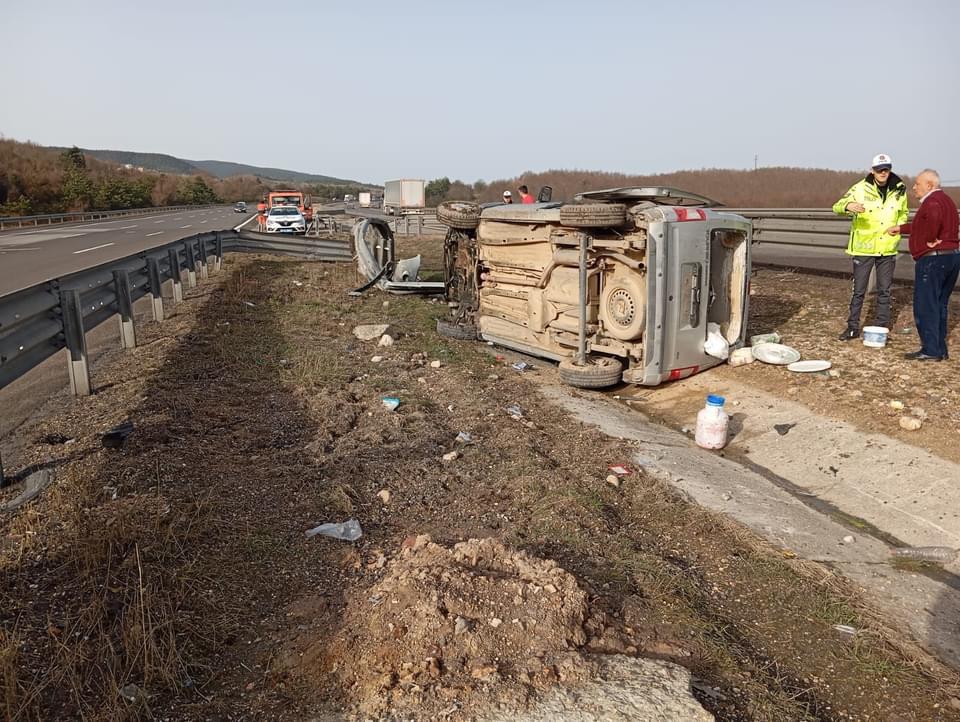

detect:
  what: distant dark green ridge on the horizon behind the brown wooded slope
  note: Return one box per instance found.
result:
[53,148,364,185]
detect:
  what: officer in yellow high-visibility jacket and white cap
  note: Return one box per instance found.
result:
[833,153,909,341]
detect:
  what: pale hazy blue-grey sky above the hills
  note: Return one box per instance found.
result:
[0,0,960,183]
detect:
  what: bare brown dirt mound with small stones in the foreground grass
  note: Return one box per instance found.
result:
[286,535,709,719]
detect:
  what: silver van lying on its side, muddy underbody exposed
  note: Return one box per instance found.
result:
[437,188,752,388]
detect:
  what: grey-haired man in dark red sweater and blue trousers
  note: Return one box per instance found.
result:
[887,168,960,361]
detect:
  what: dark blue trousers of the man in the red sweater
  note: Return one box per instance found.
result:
[913,253,960,356]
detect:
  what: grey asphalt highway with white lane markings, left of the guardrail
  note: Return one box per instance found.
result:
[0,206,256,296]
